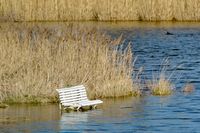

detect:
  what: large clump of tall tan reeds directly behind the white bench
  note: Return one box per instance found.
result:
[0,24,139,102]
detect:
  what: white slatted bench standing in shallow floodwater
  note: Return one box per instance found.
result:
[56,85,103,110]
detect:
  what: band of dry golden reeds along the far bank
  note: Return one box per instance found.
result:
[0,0,200,21]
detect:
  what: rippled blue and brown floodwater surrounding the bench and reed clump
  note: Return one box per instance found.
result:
[0,23,200,133]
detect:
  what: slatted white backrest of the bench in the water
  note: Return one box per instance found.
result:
[56,85,88,104]
